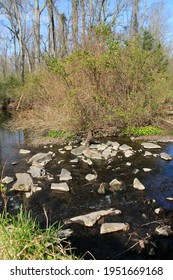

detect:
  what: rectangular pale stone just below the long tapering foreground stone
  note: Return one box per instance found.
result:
[100,223,130,234]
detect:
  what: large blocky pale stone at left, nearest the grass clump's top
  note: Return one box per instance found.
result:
[11,173,33,192]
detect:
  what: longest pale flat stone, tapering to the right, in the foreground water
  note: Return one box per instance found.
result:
[70,208,116,227]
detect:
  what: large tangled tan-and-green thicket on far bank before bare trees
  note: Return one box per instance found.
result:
[3,27,172,137]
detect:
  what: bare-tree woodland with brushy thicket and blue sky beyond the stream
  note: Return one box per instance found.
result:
[0,0,173,138]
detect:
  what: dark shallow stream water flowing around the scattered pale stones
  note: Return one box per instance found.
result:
[0,112,173,259]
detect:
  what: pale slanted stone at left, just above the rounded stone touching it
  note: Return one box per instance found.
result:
[28,152,54,167]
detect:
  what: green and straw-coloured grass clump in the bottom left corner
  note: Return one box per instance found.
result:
[0,208,76,260]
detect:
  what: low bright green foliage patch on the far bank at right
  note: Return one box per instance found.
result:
[123,126,163,137]
